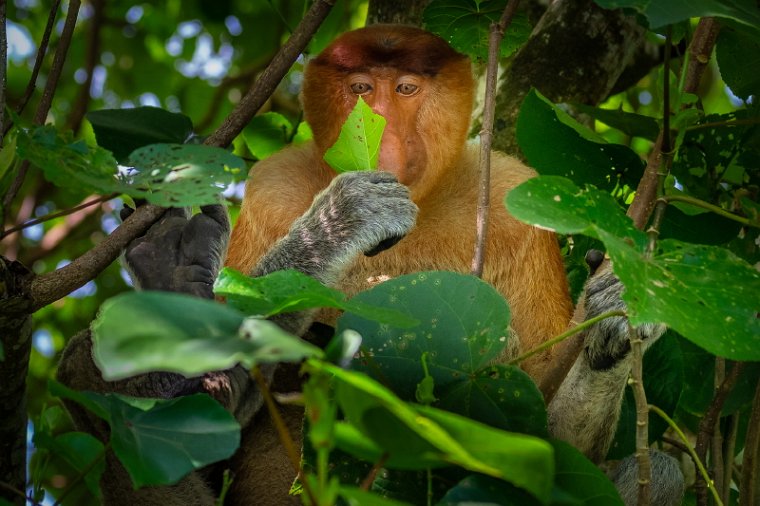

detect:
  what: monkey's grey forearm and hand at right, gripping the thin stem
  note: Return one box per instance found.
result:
[548,270,665,463]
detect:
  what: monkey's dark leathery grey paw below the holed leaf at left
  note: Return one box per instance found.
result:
[122,204,230,299]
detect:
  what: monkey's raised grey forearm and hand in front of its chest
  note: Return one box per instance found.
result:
[253,171,417,284]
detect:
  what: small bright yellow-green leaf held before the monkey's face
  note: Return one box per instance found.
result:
[324,97,385,173]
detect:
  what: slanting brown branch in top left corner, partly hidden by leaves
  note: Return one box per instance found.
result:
[3,0,81,216]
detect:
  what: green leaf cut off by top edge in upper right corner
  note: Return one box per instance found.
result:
[594,0,760,33]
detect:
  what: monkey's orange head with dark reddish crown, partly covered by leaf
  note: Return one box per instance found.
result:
[303,25,474,200]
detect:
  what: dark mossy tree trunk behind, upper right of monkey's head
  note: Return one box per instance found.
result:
[494,0,645,155]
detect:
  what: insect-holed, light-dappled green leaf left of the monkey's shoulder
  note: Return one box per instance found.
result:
[125,144,247,207]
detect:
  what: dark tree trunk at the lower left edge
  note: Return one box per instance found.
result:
[0,257,32,506]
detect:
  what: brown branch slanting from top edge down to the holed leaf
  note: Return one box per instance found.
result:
[204,0,335,147]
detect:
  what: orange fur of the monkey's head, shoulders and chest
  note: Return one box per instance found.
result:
[226,25,571,504]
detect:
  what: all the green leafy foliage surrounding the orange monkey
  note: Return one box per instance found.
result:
[0,0,760,505]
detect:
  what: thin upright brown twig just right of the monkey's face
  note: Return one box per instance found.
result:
[471,0,520,277]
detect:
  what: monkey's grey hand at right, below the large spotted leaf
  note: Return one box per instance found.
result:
[584,267,665,371]
